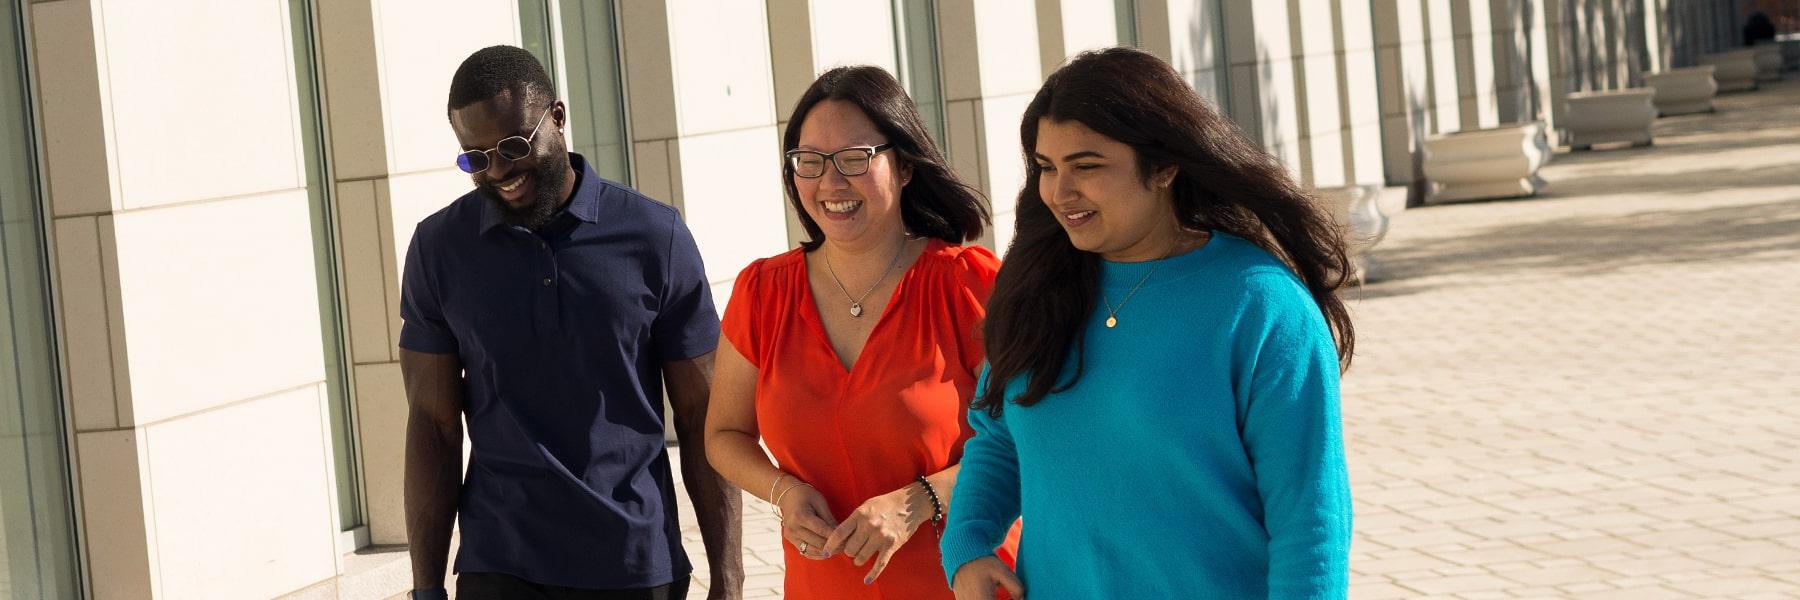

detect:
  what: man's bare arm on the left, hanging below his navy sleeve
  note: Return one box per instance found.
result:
[400,350,463,589]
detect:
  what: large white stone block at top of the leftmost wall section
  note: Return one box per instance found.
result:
[95,0,306,207]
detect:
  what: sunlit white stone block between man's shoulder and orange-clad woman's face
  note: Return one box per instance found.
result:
[673,126,788,285]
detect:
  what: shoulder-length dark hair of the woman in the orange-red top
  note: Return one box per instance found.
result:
[781,65,988,250]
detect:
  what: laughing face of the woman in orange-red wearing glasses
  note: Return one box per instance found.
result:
[790,99,913,247]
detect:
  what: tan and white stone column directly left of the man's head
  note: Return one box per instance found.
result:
[317,0,520,544]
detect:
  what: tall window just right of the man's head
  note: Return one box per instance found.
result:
[518,0,632,184]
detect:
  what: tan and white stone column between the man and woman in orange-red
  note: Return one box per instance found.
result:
[619,0,784,306]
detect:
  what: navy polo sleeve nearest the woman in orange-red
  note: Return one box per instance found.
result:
[650,216,718,362]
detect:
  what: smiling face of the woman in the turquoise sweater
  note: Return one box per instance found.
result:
[1031,117,1181,263]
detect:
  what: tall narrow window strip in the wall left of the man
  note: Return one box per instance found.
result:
[288,0,367,533]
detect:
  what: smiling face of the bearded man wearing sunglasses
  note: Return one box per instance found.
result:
[450,92,574,229]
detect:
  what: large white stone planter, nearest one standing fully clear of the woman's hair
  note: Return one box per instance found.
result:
[1420,121,1550,204]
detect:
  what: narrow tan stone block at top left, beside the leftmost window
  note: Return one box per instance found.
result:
[31,2,117,216]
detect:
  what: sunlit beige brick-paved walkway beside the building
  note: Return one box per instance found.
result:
[684,81,1800,600]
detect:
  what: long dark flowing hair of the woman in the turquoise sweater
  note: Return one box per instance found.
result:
[972,49,1355,416]
